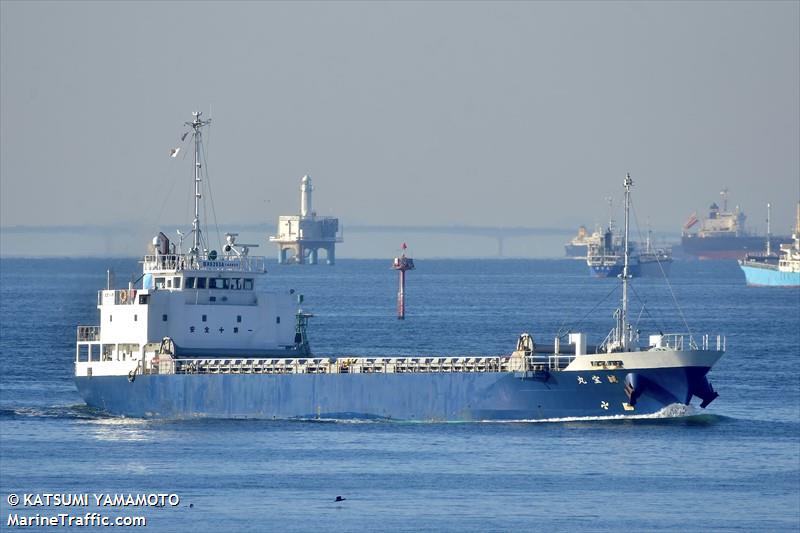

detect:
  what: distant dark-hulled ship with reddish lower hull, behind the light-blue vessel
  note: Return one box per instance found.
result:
[681,189,790,259]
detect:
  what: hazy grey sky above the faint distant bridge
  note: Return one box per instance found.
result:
[0,1,800,255]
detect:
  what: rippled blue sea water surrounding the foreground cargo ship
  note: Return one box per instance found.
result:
[0,259,800,531]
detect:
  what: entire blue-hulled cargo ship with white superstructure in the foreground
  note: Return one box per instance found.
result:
[75,112,725,421]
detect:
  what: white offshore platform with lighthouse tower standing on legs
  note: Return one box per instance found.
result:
[269,175,342,265]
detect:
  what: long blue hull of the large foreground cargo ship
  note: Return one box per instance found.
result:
[76,367,709,421]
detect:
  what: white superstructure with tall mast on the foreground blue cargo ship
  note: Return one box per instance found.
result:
[75,113,308,376]
